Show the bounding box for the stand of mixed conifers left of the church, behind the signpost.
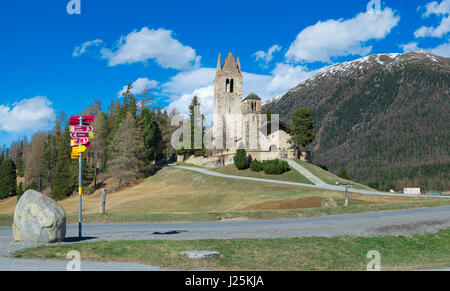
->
[0,85,176,200]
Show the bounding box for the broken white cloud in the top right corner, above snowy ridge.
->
[414,0,450,38]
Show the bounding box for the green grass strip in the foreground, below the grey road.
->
[15,229,450,271]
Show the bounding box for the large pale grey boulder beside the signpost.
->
[13,190,66,243]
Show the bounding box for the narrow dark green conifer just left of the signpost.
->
[52,126,74,200]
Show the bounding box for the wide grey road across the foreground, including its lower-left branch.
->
[0,206,450,270]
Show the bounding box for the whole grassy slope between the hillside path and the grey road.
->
[0,168,450,226]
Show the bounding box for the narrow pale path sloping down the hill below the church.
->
[169,164,450,199]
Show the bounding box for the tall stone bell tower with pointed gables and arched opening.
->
[213,53,243,152]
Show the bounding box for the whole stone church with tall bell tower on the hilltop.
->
[182,53,295,167]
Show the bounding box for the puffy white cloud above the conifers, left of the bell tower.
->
[101,27,200,69]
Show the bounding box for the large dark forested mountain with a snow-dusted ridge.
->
[266,52,450,190]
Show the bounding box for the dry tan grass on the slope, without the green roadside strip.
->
[0,168,446,219]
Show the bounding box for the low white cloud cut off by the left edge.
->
[0,96,56,133]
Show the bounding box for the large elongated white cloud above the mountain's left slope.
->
[285,8,400,63]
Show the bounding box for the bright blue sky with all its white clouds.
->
[0,0,450,145]
